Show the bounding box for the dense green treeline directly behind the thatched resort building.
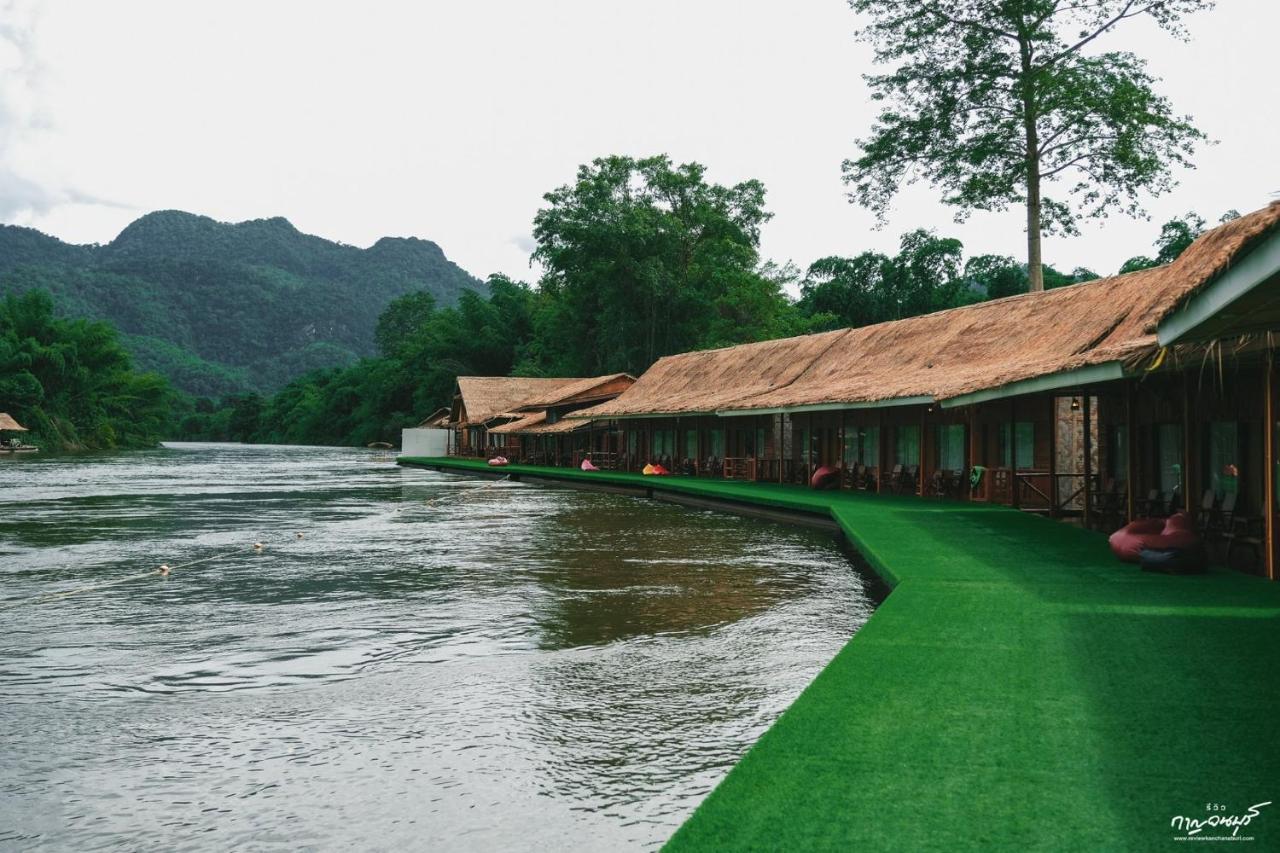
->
[179,158,1203,444]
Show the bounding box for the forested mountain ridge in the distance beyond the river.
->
[0,210,485,396]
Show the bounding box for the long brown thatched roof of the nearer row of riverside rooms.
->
[586,202,1280,418]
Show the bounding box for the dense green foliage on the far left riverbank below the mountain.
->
[0,291,172,450]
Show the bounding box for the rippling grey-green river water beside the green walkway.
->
[0,444,873,850]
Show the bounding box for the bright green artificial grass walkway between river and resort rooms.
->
[402,457,1280,850]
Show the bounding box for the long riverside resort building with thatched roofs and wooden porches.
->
[444,202,1280,579]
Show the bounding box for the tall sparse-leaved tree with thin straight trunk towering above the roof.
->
[844,0,1212,291]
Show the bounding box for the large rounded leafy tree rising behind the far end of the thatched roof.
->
[532,156,769,375]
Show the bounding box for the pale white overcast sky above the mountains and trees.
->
[0,0,1280,285]
